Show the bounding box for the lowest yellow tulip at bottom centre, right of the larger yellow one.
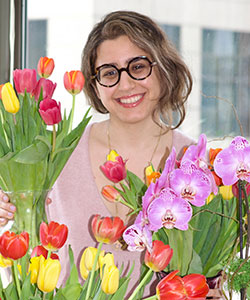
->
[101,265,119,295]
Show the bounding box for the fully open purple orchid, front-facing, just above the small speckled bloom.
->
[147,188,192,231]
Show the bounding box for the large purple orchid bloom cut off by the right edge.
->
[214,136,250,185]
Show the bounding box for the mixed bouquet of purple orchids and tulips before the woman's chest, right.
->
[101,134,250,298]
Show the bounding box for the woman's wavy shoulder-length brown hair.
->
[81,11,192,128]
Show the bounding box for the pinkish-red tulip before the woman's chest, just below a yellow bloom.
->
[100,156,127,183]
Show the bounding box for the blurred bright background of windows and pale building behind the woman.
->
[0,0,250,144]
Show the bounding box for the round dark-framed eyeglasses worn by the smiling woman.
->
[91,56,157,87]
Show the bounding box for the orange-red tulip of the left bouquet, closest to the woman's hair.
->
[63,71,85,95]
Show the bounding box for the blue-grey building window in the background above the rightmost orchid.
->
[202,29,250,136]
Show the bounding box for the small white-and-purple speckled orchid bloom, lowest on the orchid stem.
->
[123,223,152,252]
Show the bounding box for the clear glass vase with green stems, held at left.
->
[5,190,49,249]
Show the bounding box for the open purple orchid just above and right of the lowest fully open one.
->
[169,160,211,207]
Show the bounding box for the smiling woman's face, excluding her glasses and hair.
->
[95,35,160,123]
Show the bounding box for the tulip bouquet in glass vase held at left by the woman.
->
[0,57,90,248]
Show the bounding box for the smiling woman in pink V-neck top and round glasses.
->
[0,11,219,294]
